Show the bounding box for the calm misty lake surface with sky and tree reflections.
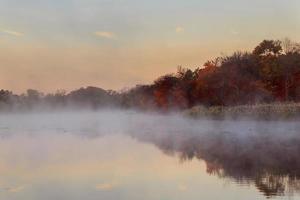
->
[0,112,300,200]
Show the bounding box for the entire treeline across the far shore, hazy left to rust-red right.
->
[0,39,300,110]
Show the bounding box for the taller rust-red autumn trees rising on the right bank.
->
[124,39,300,109]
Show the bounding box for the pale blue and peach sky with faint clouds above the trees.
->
[0,0,300,93]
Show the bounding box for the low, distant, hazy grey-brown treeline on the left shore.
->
[0,87,120,111]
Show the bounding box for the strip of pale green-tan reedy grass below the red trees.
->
[184,103,300,120]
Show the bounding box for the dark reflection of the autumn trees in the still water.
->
[132,130,300,197]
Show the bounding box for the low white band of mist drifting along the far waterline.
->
[0,109,300,137]
